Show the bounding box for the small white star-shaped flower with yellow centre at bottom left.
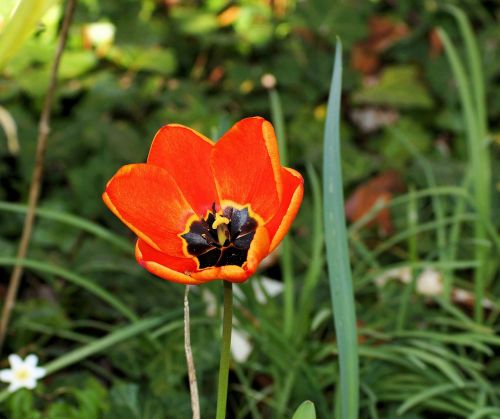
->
[0,354,46,393]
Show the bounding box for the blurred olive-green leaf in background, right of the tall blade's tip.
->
[353,65,433,109]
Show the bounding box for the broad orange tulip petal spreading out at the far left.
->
[103,164,193,257]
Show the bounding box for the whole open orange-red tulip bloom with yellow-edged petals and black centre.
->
[103,117,303,284]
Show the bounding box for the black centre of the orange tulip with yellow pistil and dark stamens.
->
[181,204,258,269]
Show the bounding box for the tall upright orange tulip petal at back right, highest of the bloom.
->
[211,117,282,221]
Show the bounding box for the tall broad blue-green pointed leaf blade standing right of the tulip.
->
[323,40,359,419]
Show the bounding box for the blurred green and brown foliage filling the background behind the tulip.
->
[0,0,500,419]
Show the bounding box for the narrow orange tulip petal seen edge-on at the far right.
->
[266,167,304,252]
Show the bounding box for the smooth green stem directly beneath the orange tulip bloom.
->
[216,281,233,419]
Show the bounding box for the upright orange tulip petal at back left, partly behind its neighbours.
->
[148,124,219,215]
